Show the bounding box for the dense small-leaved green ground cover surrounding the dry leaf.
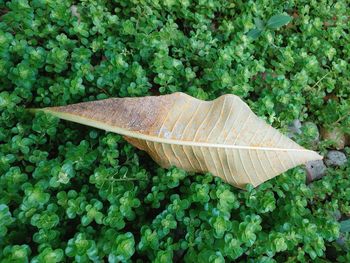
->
[0,0,350,263]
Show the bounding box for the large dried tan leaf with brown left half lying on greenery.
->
[33,93,322,188]
